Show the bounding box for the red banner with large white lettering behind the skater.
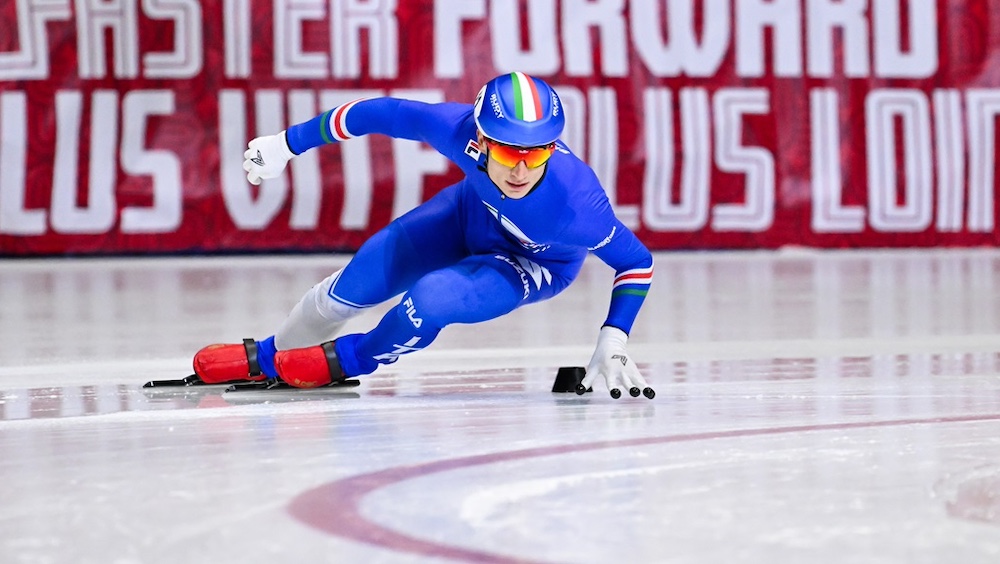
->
[0,0,1000,256]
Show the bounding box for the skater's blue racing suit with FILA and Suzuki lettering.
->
[262,98,653,376]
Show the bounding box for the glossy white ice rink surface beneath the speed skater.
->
[0,249,1000,564]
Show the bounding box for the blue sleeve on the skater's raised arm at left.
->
[288,98,472,161]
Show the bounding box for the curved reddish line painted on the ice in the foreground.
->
[288,414,1000,563]
